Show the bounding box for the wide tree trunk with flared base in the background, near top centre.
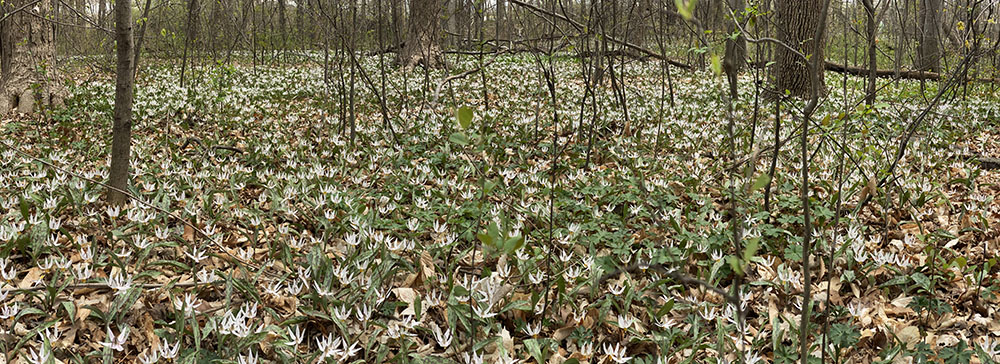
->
[396,0,446,68]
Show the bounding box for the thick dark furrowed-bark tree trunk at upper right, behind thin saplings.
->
[774,0,826,97]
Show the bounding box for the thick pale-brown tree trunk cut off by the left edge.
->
[0,0,63,115]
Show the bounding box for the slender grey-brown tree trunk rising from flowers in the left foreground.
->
[108,0,134,205]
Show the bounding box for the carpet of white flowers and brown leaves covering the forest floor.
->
[0,56,1000,363]
